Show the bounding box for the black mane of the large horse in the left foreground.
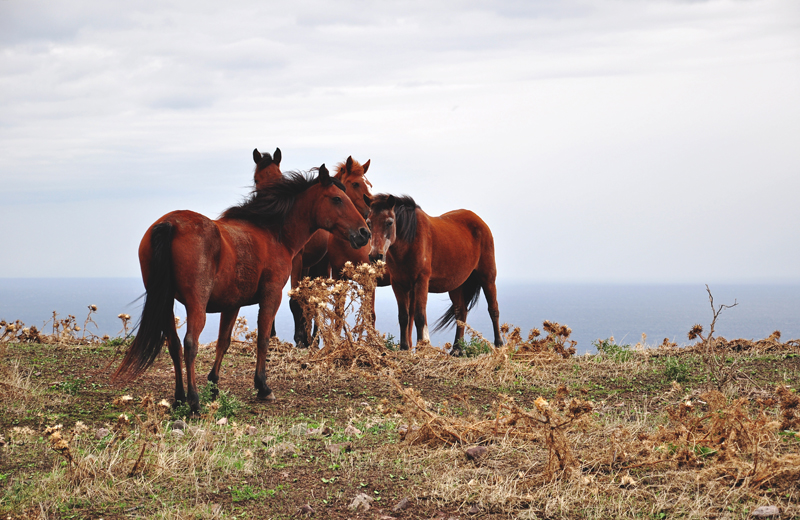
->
[220,170,346,231]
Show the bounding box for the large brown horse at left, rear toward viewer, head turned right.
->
[114,164,370,412]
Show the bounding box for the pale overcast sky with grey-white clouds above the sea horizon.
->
[0,0,800,283]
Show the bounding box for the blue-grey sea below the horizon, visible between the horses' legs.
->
[0,278,800,353]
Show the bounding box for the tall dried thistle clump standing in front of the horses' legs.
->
[289,262,395,368]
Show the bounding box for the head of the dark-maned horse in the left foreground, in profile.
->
[313,164,370,249]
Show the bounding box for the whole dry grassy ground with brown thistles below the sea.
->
[0,294,800,519]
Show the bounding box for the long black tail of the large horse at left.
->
[112,222,175,381]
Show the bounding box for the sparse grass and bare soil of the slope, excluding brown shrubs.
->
[0,344,800,518]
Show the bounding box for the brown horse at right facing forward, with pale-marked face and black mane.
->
[365,194,503,354]
